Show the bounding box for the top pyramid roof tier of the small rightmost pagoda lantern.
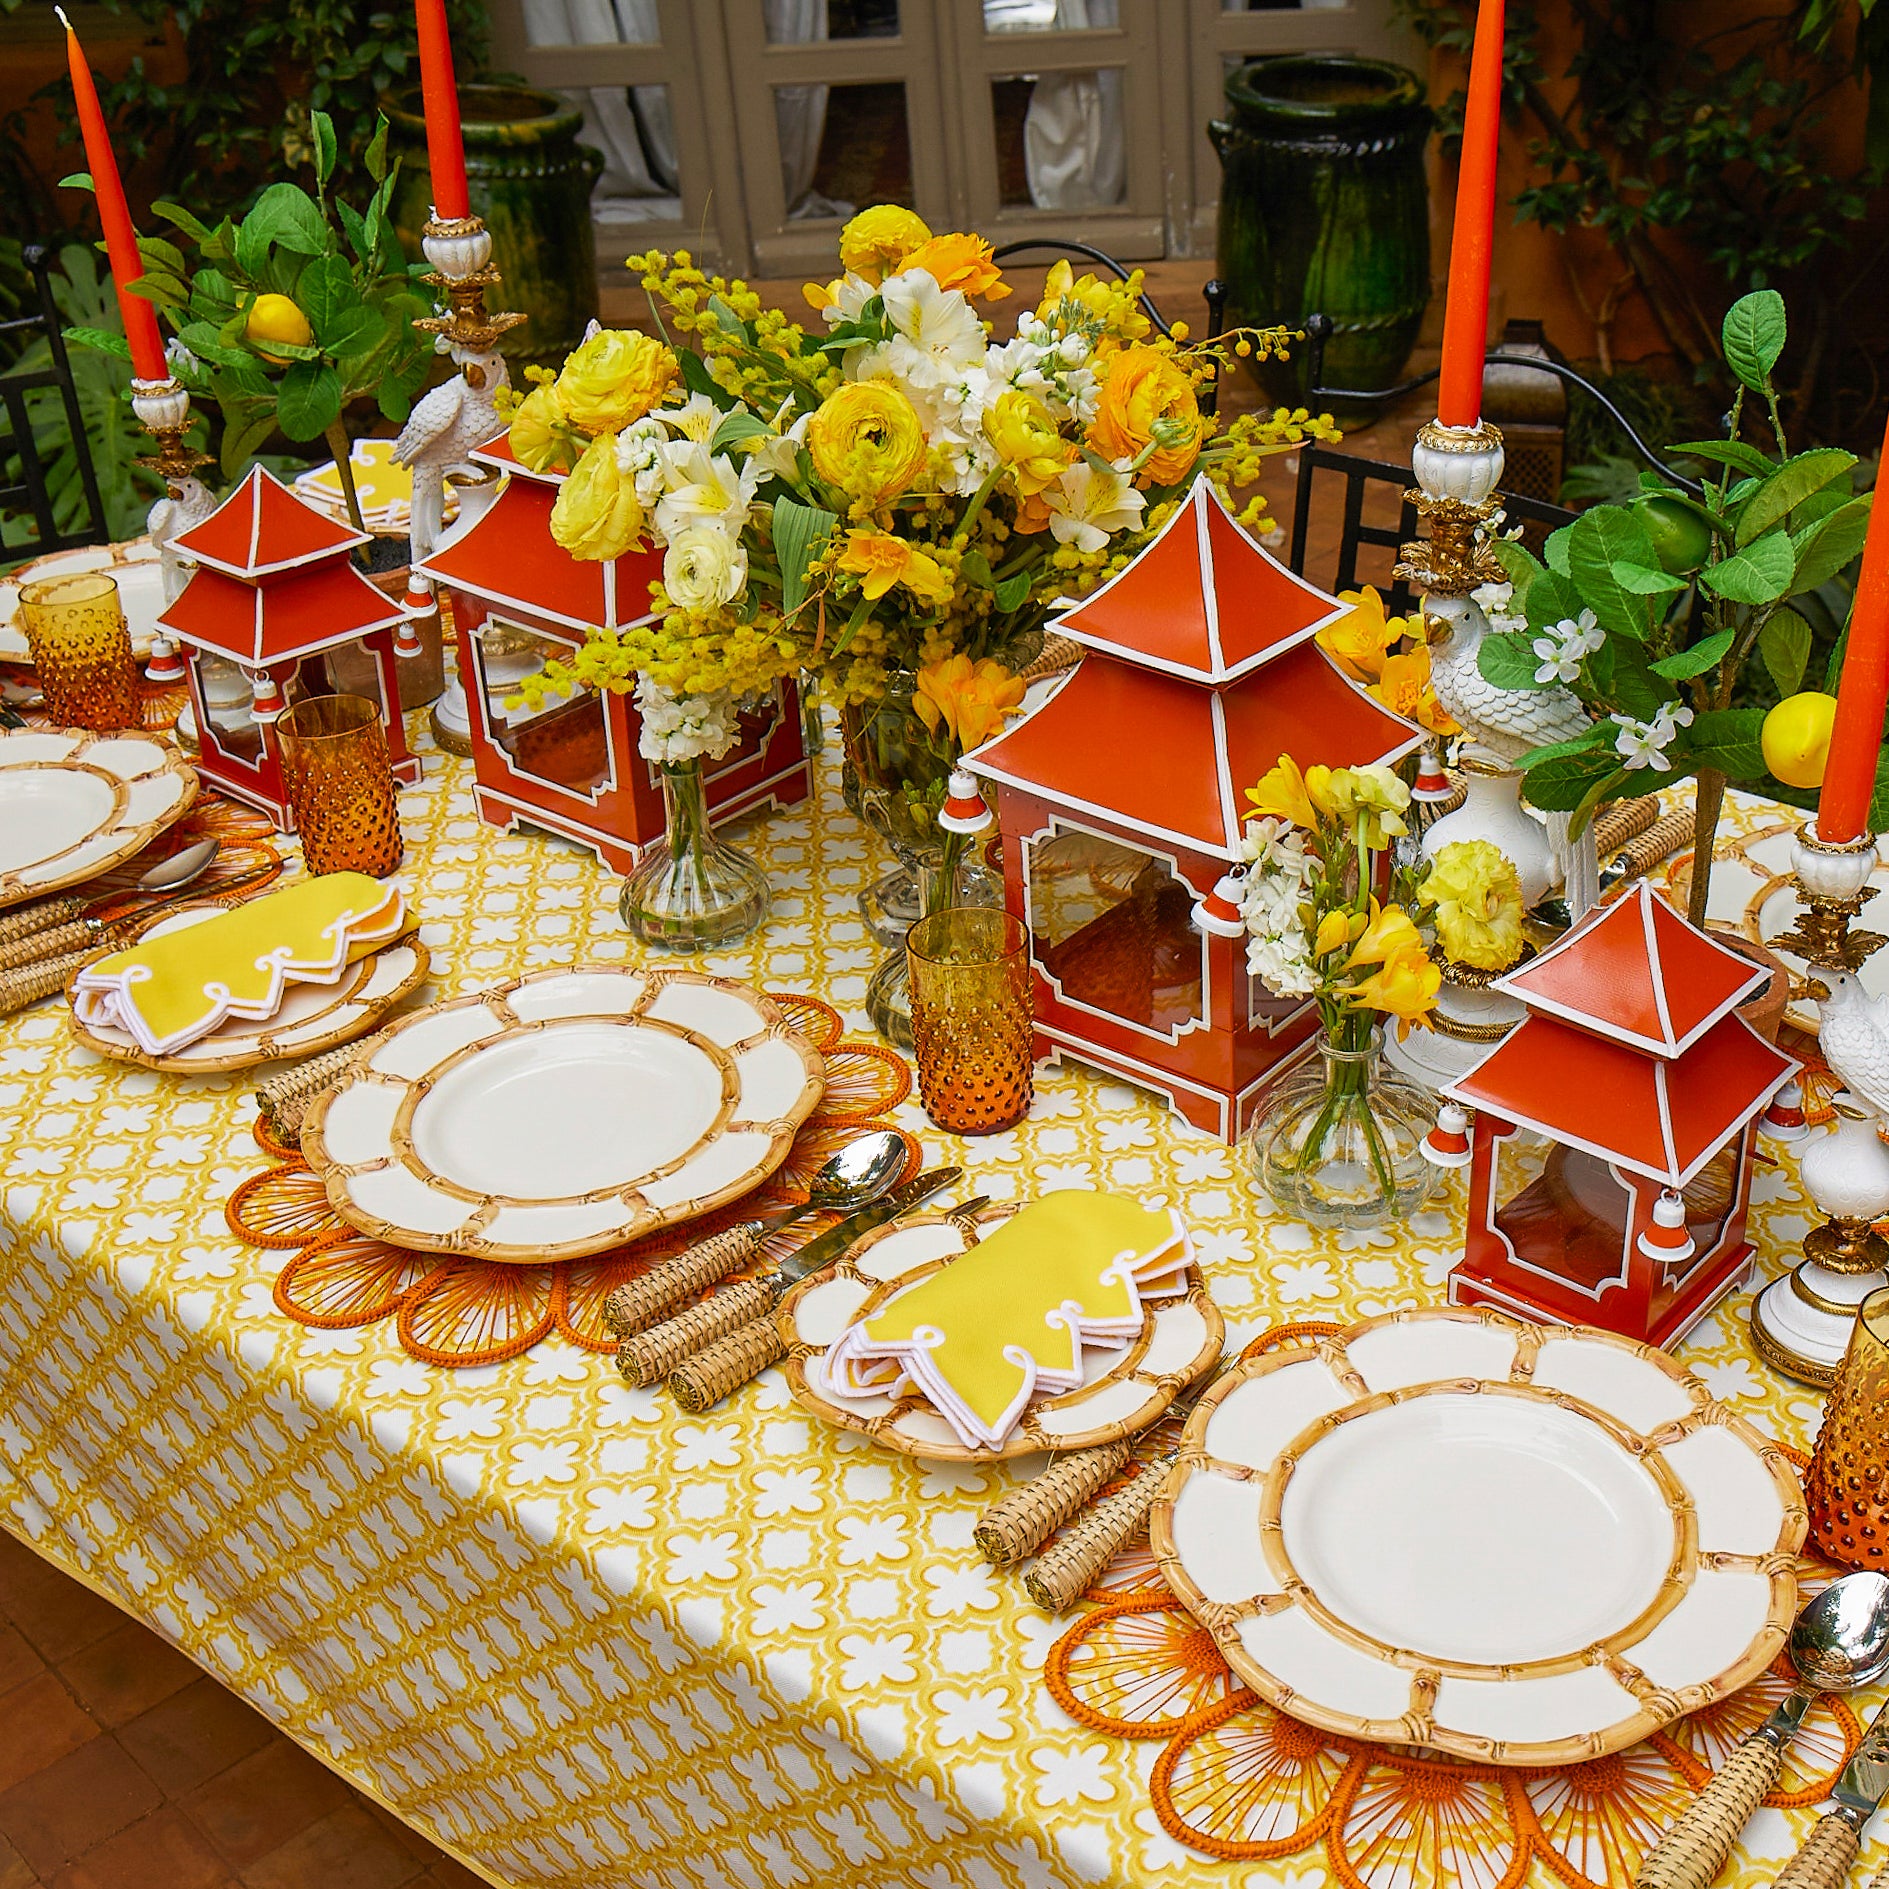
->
[1494,880,1770,1056]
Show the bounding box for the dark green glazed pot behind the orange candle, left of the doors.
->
[387,85,603,365]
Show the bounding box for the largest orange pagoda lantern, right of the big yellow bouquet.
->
[965,480,1422,1141]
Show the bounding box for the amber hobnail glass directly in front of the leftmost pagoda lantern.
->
[276,695,400,878]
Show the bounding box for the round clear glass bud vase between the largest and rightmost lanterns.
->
[1247,1030,1436,1228]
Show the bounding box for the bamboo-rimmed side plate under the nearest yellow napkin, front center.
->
[774,1207,1226,1462]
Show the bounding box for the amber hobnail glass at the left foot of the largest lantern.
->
[905,905,1033,1135]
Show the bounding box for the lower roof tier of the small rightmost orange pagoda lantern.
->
[1443,1016,1796,1188]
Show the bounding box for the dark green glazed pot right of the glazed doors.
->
[1207,53,1430,406]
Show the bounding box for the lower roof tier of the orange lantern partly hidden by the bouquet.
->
[419,476,663,631]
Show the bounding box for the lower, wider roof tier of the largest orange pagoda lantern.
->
[965,646,1424,859]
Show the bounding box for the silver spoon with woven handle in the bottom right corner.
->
[1634,1572,1889,1889]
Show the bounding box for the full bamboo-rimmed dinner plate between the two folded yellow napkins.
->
[302,965,825,1264]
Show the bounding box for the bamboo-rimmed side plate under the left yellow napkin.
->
[66,899,427,1075]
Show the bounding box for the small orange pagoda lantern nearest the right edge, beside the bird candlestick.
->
[1432,882,1796,1345]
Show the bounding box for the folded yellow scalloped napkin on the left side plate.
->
[72,873,406,1056]
